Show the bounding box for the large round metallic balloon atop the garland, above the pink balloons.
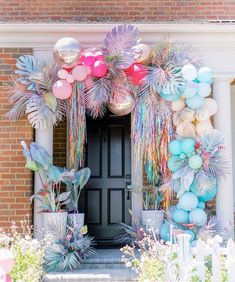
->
[53,37,82,68]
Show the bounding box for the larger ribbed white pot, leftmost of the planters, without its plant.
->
[42,212,68,240]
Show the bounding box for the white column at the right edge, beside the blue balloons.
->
[213,77,234,237]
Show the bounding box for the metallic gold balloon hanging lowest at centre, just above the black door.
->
[108,93,136,116]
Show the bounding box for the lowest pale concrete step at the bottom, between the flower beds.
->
[43,268,136,282]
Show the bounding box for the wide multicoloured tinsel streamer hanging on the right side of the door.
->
[132,93,174,207]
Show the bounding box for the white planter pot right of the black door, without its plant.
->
[142,210,164,234]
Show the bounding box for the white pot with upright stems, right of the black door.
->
[142,185,164,233]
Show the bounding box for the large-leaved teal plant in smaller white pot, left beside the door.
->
[61,167,91,228]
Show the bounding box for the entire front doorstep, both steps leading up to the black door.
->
[43,249,136,282]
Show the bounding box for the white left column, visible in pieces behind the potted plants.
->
[33,127,53,238]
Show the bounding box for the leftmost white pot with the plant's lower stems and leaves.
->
[30,181,70,240]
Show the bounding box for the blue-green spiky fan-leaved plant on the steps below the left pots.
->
[44,218,95,272]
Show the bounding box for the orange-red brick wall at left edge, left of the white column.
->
[0,48,33,228]
